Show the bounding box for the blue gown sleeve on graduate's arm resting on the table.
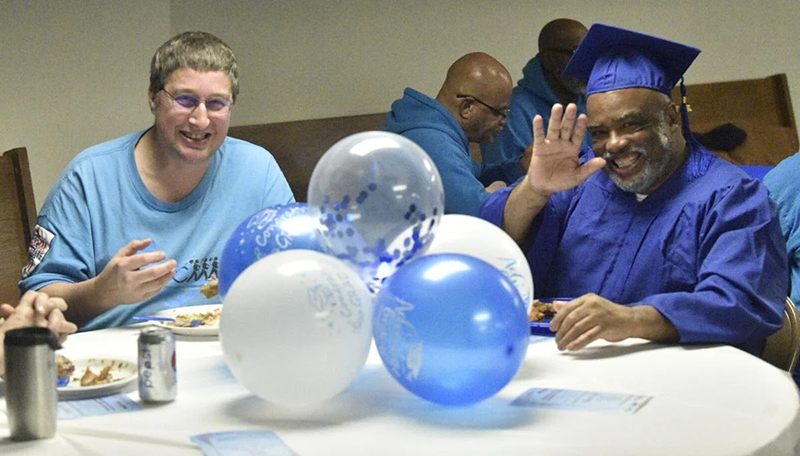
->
[631,180,788,348]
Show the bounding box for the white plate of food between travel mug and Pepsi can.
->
[58,358,138,399]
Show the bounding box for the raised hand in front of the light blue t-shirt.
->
[92,239,177,308]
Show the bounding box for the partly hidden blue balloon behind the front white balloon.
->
[217,203,323,296]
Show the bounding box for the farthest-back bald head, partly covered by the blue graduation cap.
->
[539,19,588,103]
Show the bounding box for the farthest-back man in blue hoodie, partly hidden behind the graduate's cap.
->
[481,19,591,184]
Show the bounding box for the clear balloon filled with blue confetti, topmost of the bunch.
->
[308,131,444,291]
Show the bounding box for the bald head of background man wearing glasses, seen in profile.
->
[436,52,513,143]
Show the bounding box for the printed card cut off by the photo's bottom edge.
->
[192,430,299,456]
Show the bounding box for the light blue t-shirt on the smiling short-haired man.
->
[20,131,294,330]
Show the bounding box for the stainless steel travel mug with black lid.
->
[3,328,60,440]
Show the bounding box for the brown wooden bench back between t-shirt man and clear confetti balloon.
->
[228,113,386,202]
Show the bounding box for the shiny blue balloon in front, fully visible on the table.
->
[372,254,529,406]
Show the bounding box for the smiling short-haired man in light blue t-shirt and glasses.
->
[20,32,294,330]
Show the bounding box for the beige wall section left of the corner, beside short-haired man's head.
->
[0,0,170,207]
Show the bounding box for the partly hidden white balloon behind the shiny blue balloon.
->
[425,214,533,313]
